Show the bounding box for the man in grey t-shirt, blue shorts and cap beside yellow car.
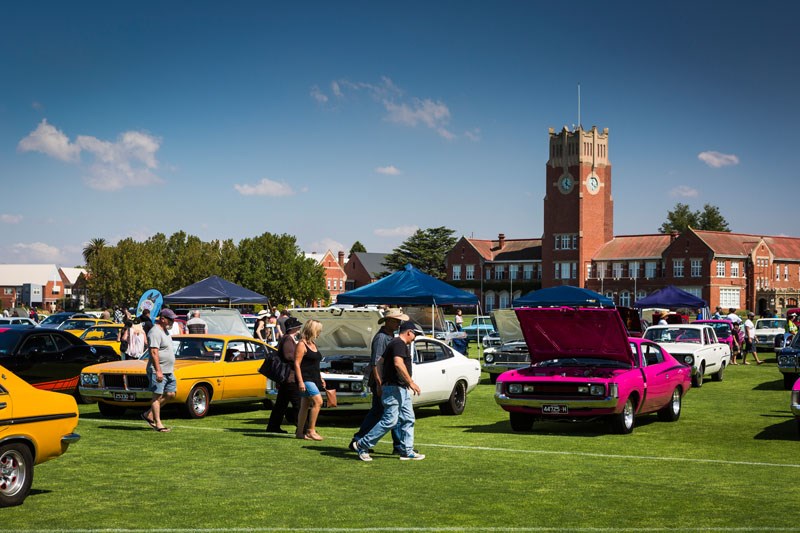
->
[142,309,178,433]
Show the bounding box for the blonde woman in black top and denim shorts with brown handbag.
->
[294,320,325,440]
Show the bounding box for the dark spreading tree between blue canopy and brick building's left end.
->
[381,226,457,279]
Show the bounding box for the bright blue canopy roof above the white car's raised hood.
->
[336,264,478,305]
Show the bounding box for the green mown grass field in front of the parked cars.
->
[7,352,800,531]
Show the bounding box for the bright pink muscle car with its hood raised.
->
[495,307,692,433]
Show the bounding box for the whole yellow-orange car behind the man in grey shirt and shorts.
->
[78,334,273,418]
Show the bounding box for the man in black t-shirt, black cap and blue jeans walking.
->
[350,320,425,461]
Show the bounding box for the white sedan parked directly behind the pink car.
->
[644,324,731,387]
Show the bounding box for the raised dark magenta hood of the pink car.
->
[515,307,633,364]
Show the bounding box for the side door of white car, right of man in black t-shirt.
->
[411,338,453,403]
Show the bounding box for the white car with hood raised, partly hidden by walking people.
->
[267,307,481,415]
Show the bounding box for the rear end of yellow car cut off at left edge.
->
[0,366,80,507]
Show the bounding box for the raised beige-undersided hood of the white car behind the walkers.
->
[289,307,383,357]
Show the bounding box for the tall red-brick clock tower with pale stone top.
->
[542,126,614,287]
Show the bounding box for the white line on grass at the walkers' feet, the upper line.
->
[76,418,800,468]
